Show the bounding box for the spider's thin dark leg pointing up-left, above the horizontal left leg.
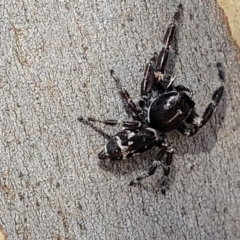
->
[110,70,141,115]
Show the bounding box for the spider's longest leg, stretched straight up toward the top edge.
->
[154,4,182,81]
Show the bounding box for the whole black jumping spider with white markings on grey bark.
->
[78,5,224,194]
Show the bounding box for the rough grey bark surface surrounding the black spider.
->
[0,0,240,240]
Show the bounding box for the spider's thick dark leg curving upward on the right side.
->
[177,86,224,136]
